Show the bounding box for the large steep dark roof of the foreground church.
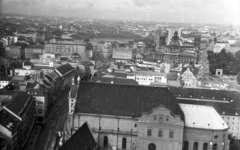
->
[76,82,184,120]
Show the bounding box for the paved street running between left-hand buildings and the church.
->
[34,90,68,150]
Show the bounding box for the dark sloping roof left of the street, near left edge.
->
[6,91,33,117]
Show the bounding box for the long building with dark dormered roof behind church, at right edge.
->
[170,87,240,139]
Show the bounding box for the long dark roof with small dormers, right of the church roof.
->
[170,87,240,115]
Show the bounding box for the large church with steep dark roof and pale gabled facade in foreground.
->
[68,82,229,150]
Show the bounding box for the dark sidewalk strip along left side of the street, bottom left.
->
[23,125,42,150]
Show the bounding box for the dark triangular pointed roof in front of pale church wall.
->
[60,122,97,150]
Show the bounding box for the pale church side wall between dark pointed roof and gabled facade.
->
[73,114,137,150]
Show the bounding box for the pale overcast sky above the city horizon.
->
[0,0,240,25]
